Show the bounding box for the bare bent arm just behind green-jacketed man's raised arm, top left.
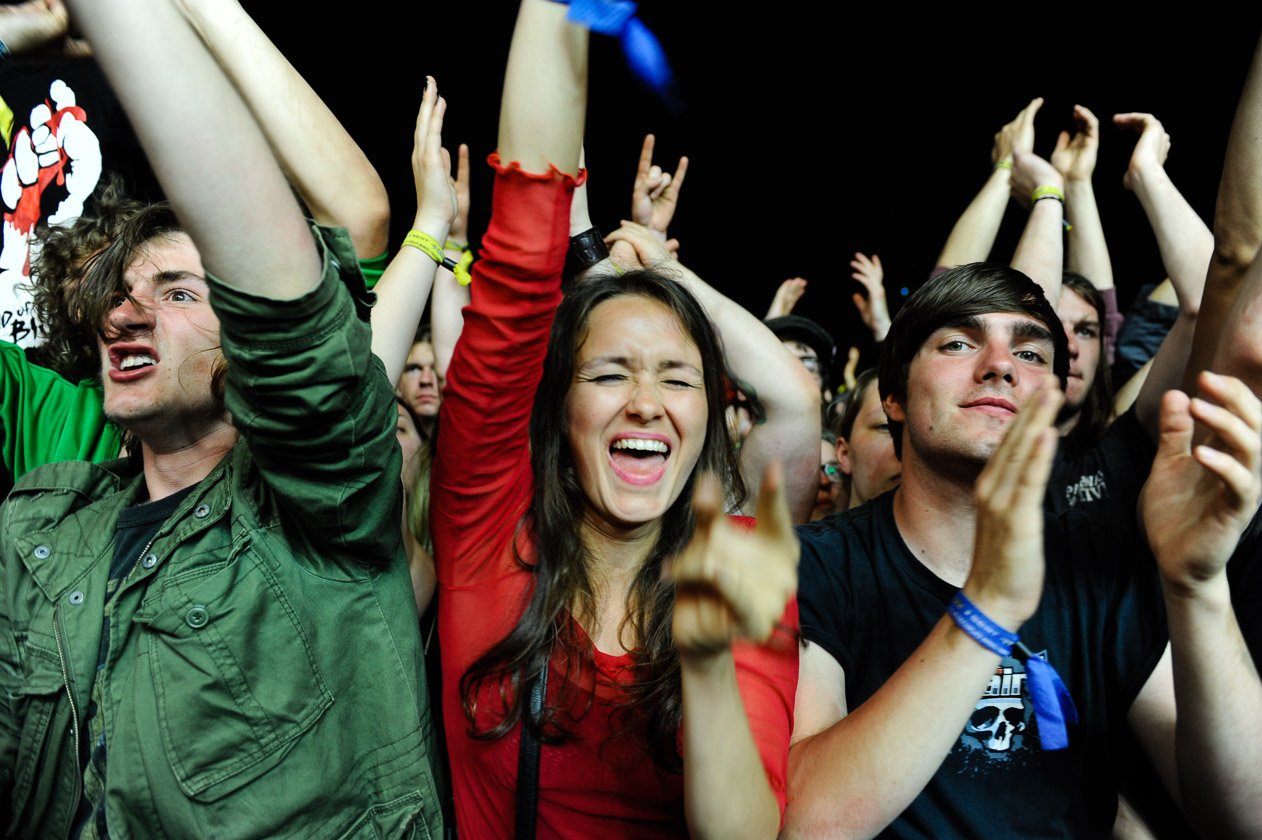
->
[175,0,390,260]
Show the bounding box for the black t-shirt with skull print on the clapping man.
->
[798,492,1166,839]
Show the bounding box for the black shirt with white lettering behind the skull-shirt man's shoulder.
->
[1044,407,1157,518]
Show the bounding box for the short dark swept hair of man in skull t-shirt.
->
[877,262,1069,459]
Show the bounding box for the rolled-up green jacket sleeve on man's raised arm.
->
[209,226,403,565]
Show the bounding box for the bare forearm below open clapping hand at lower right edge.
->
[1165,571,1262,837]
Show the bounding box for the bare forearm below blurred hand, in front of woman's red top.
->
[680,650,780,837]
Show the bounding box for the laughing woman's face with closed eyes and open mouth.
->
[564,295,708,531]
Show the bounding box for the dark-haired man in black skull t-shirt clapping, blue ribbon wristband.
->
[785,265,1262,837]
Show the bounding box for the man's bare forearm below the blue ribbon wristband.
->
[784,615,1000,837]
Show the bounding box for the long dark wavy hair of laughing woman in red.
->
[461,270,745,772]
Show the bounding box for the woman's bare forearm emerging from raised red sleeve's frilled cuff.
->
[500,0,588,173]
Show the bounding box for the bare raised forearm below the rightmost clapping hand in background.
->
[1131,168,1214,314]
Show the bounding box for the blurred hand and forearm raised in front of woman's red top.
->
[670,465,799,839]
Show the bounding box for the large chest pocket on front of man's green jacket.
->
[136,539,333,802]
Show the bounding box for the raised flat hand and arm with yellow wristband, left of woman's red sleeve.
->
[372,78,457,385]
